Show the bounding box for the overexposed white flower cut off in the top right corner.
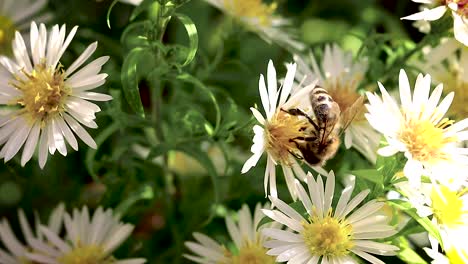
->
[401,0,468,46]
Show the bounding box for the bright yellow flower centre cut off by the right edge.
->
[431,185,468,227]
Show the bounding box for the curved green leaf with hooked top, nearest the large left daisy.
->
[120,48,152,117]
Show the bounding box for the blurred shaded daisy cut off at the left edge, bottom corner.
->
[0,204,65,264]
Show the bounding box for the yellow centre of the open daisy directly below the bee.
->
[302,211,353,257]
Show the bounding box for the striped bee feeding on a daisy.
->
[282,87,364,166]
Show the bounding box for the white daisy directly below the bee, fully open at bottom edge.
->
[263,172,398,264]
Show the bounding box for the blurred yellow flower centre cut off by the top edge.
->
[224,0,277,26]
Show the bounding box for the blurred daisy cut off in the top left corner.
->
[0,0,51,54]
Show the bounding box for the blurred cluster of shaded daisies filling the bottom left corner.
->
[0,204,146,264]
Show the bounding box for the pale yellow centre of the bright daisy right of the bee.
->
[399,117,456,163]
